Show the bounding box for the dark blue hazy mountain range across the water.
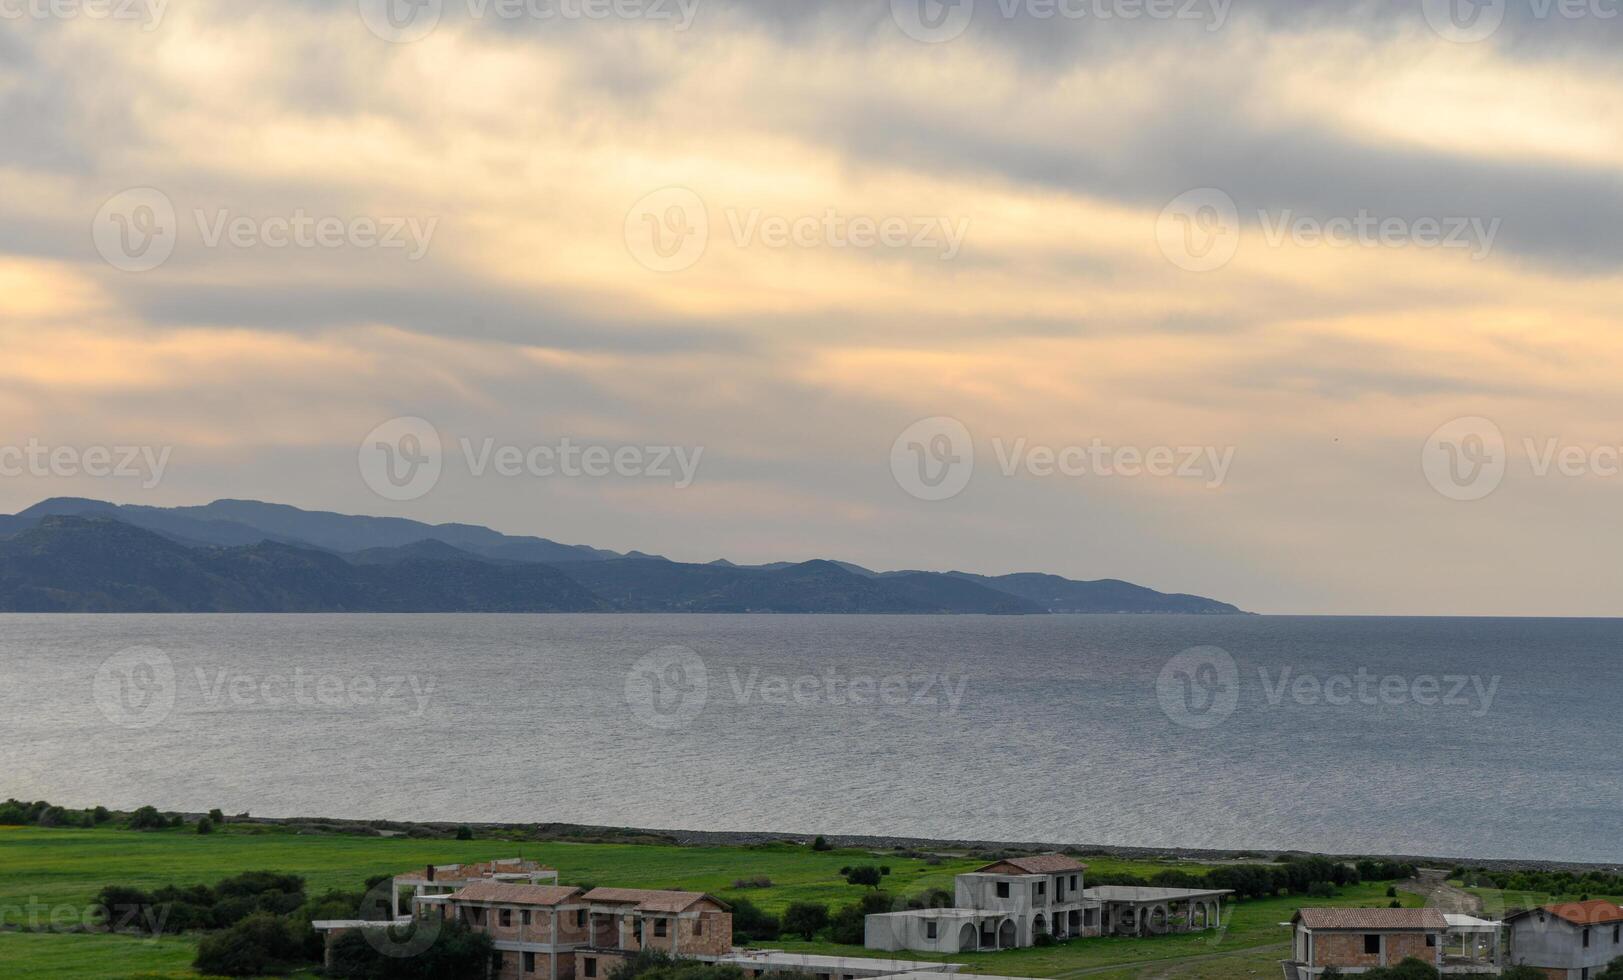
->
[0,498,1240,615]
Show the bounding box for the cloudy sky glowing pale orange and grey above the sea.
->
[0,0,1623,615]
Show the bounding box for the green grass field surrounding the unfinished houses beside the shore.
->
[0,826,1571,980]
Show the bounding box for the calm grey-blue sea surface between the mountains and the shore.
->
[0,615,1623,862]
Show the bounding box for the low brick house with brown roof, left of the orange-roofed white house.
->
[1285,909,1448,980]
